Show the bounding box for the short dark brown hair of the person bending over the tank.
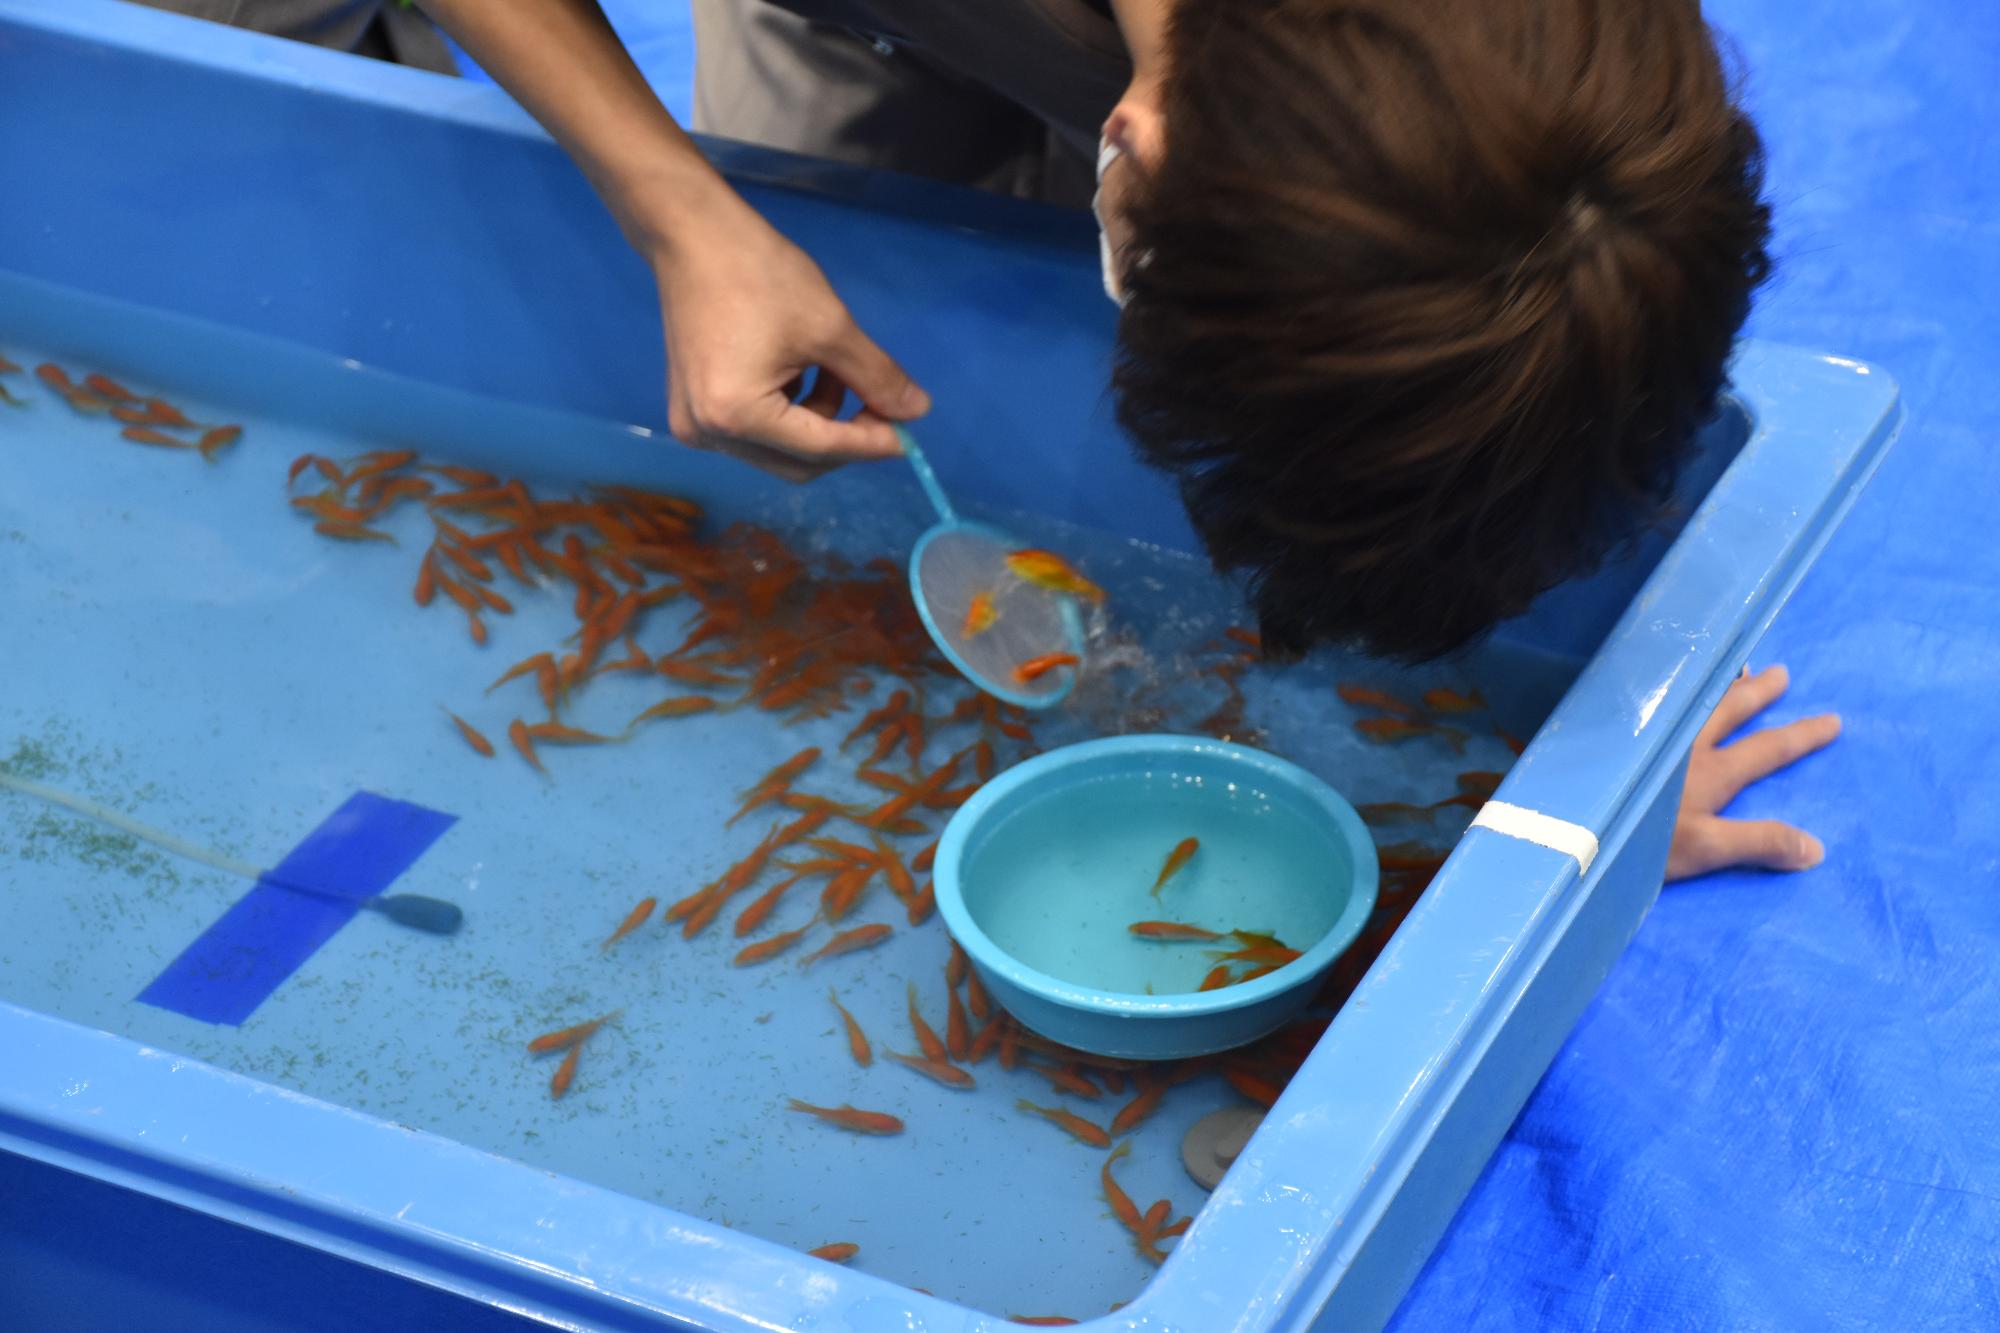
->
[1116,0,1770,656]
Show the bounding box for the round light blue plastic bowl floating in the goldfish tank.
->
[934,735,1378,1059]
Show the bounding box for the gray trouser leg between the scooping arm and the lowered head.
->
[692,0,1110,208]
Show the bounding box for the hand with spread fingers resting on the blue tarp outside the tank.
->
[1666,667,1840,881]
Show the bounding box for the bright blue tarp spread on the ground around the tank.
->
[372,0,2000,1333]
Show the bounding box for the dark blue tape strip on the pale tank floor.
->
[138,791,458,1025]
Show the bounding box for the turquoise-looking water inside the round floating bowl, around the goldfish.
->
[964,771,1354,995]
